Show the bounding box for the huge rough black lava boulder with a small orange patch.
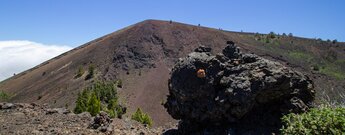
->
[164,41,315,134]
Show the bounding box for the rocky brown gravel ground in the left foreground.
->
[0,103,175,135]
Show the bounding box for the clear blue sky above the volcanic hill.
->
[0,0,345,47]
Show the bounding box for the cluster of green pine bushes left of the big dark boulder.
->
[74,81,126,118]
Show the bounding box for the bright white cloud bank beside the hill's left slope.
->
[0,40,72,81]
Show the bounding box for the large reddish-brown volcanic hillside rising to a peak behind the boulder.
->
[0,20,345,126]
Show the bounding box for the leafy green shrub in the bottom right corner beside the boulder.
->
[280,107,345,135]
